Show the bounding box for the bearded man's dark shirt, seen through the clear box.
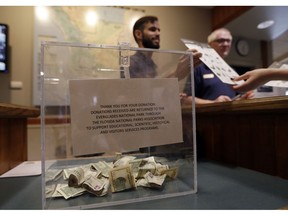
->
[129,51,157,78]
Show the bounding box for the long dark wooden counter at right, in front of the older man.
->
[182,96,288,179]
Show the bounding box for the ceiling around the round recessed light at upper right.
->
[226,6,288,59]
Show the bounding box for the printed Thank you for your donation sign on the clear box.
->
[69,78,183,156]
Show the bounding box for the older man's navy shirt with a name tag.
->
[184,63,237,100]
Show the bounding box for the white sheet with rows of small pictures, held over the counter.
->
[181,39,243,85]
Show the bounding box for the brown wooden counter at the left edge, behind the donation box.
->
[0,103,40,175]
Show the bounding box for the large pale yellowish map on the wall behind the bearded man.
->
[33,6,144,105]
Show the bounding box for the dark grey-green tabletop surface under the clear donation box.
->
[0,161,288,210]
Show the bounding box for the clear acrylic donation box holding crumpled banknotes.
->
[39,42,197,209]
